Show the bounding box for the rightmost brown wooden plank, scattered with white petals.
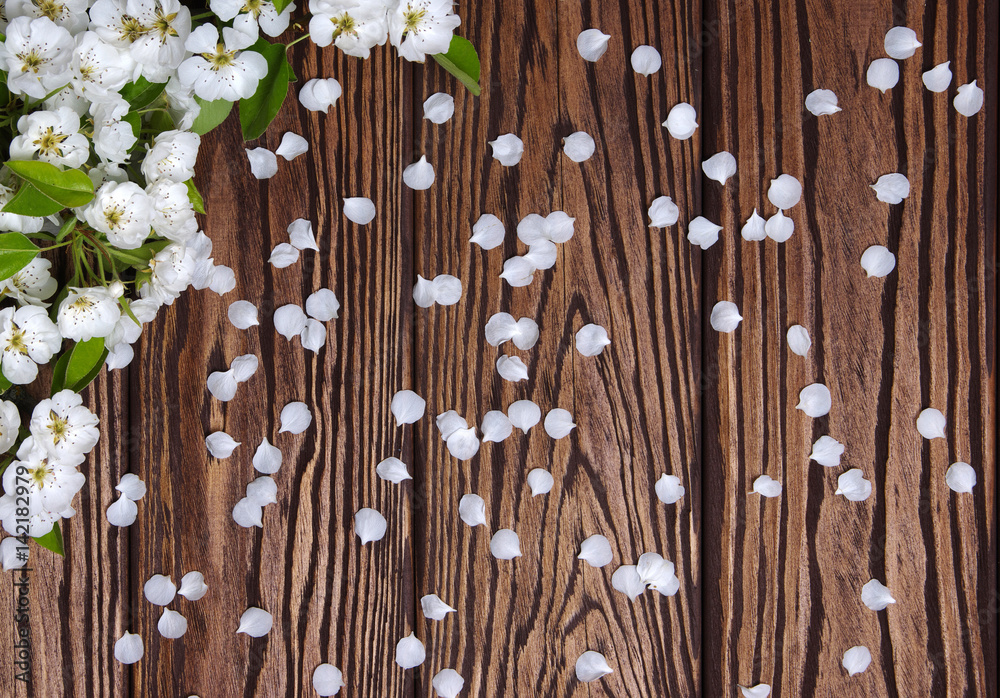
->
[703,0,996,696]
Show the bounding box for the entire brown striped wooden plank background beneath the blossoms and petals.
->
[0,0,1000,698]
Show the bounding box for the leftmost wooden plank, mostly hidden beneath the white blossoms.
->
[0,369,136,698]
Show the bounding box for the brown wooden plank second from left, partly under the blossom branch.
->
[132,44,413,696]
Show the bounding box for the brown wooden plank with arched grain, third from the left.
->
[414,2,699,696]
